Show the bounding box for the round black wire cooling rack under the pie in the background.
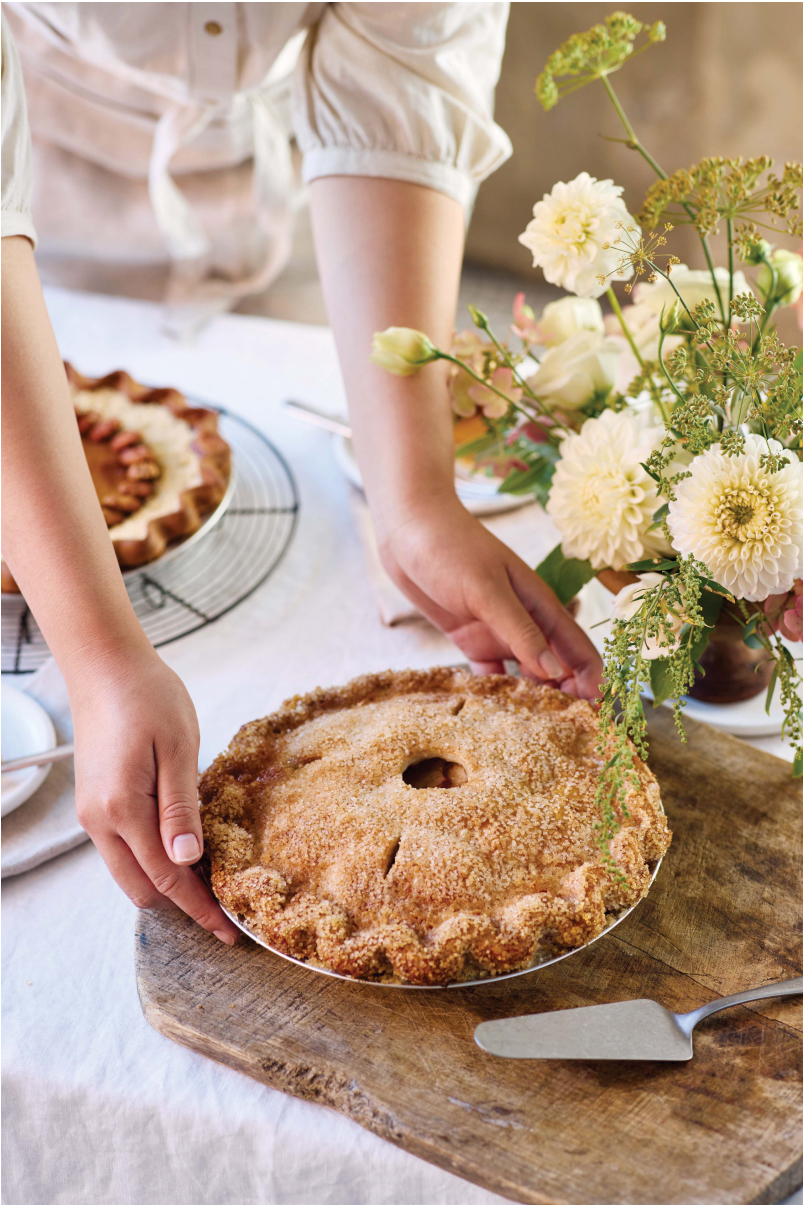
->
[2,407,299,674]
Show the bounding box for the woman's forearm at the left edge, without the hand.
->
[2,237,150,682]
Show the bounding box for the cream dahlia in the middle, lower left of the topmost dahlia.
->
[546,410,669,569]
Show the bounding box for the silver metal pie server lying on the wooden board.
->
[474,977,803,1063]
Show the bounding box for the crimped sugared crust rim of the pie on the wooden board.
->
[199,666,672,986]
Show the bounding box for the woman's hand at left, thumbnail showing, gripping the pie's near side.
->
[69,651,238,945]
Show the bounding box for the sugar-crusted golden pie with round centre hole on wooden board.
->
[200,668,672,984]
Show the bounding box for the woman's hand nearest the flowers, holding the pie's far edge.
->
[379,496,603,700]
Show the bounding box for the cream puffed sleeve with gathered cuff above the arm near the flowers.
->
[293,4,511,208]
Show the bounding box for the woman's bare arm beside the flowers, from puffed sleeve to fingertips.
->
[311,176,602,699]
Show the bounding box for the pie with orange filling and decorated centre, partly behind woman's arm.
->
[2,364,231,593]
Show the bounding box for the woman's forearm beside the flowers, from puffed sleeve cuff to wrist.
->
[311,176,464,537]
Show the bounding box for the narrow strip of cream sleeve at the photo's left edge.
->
[0,14,36,246]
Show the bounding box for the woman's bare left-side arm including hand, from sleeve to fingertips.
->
[2,237,236,944]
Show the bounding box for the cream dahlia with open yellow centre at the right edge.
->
[668,435,803,603]
